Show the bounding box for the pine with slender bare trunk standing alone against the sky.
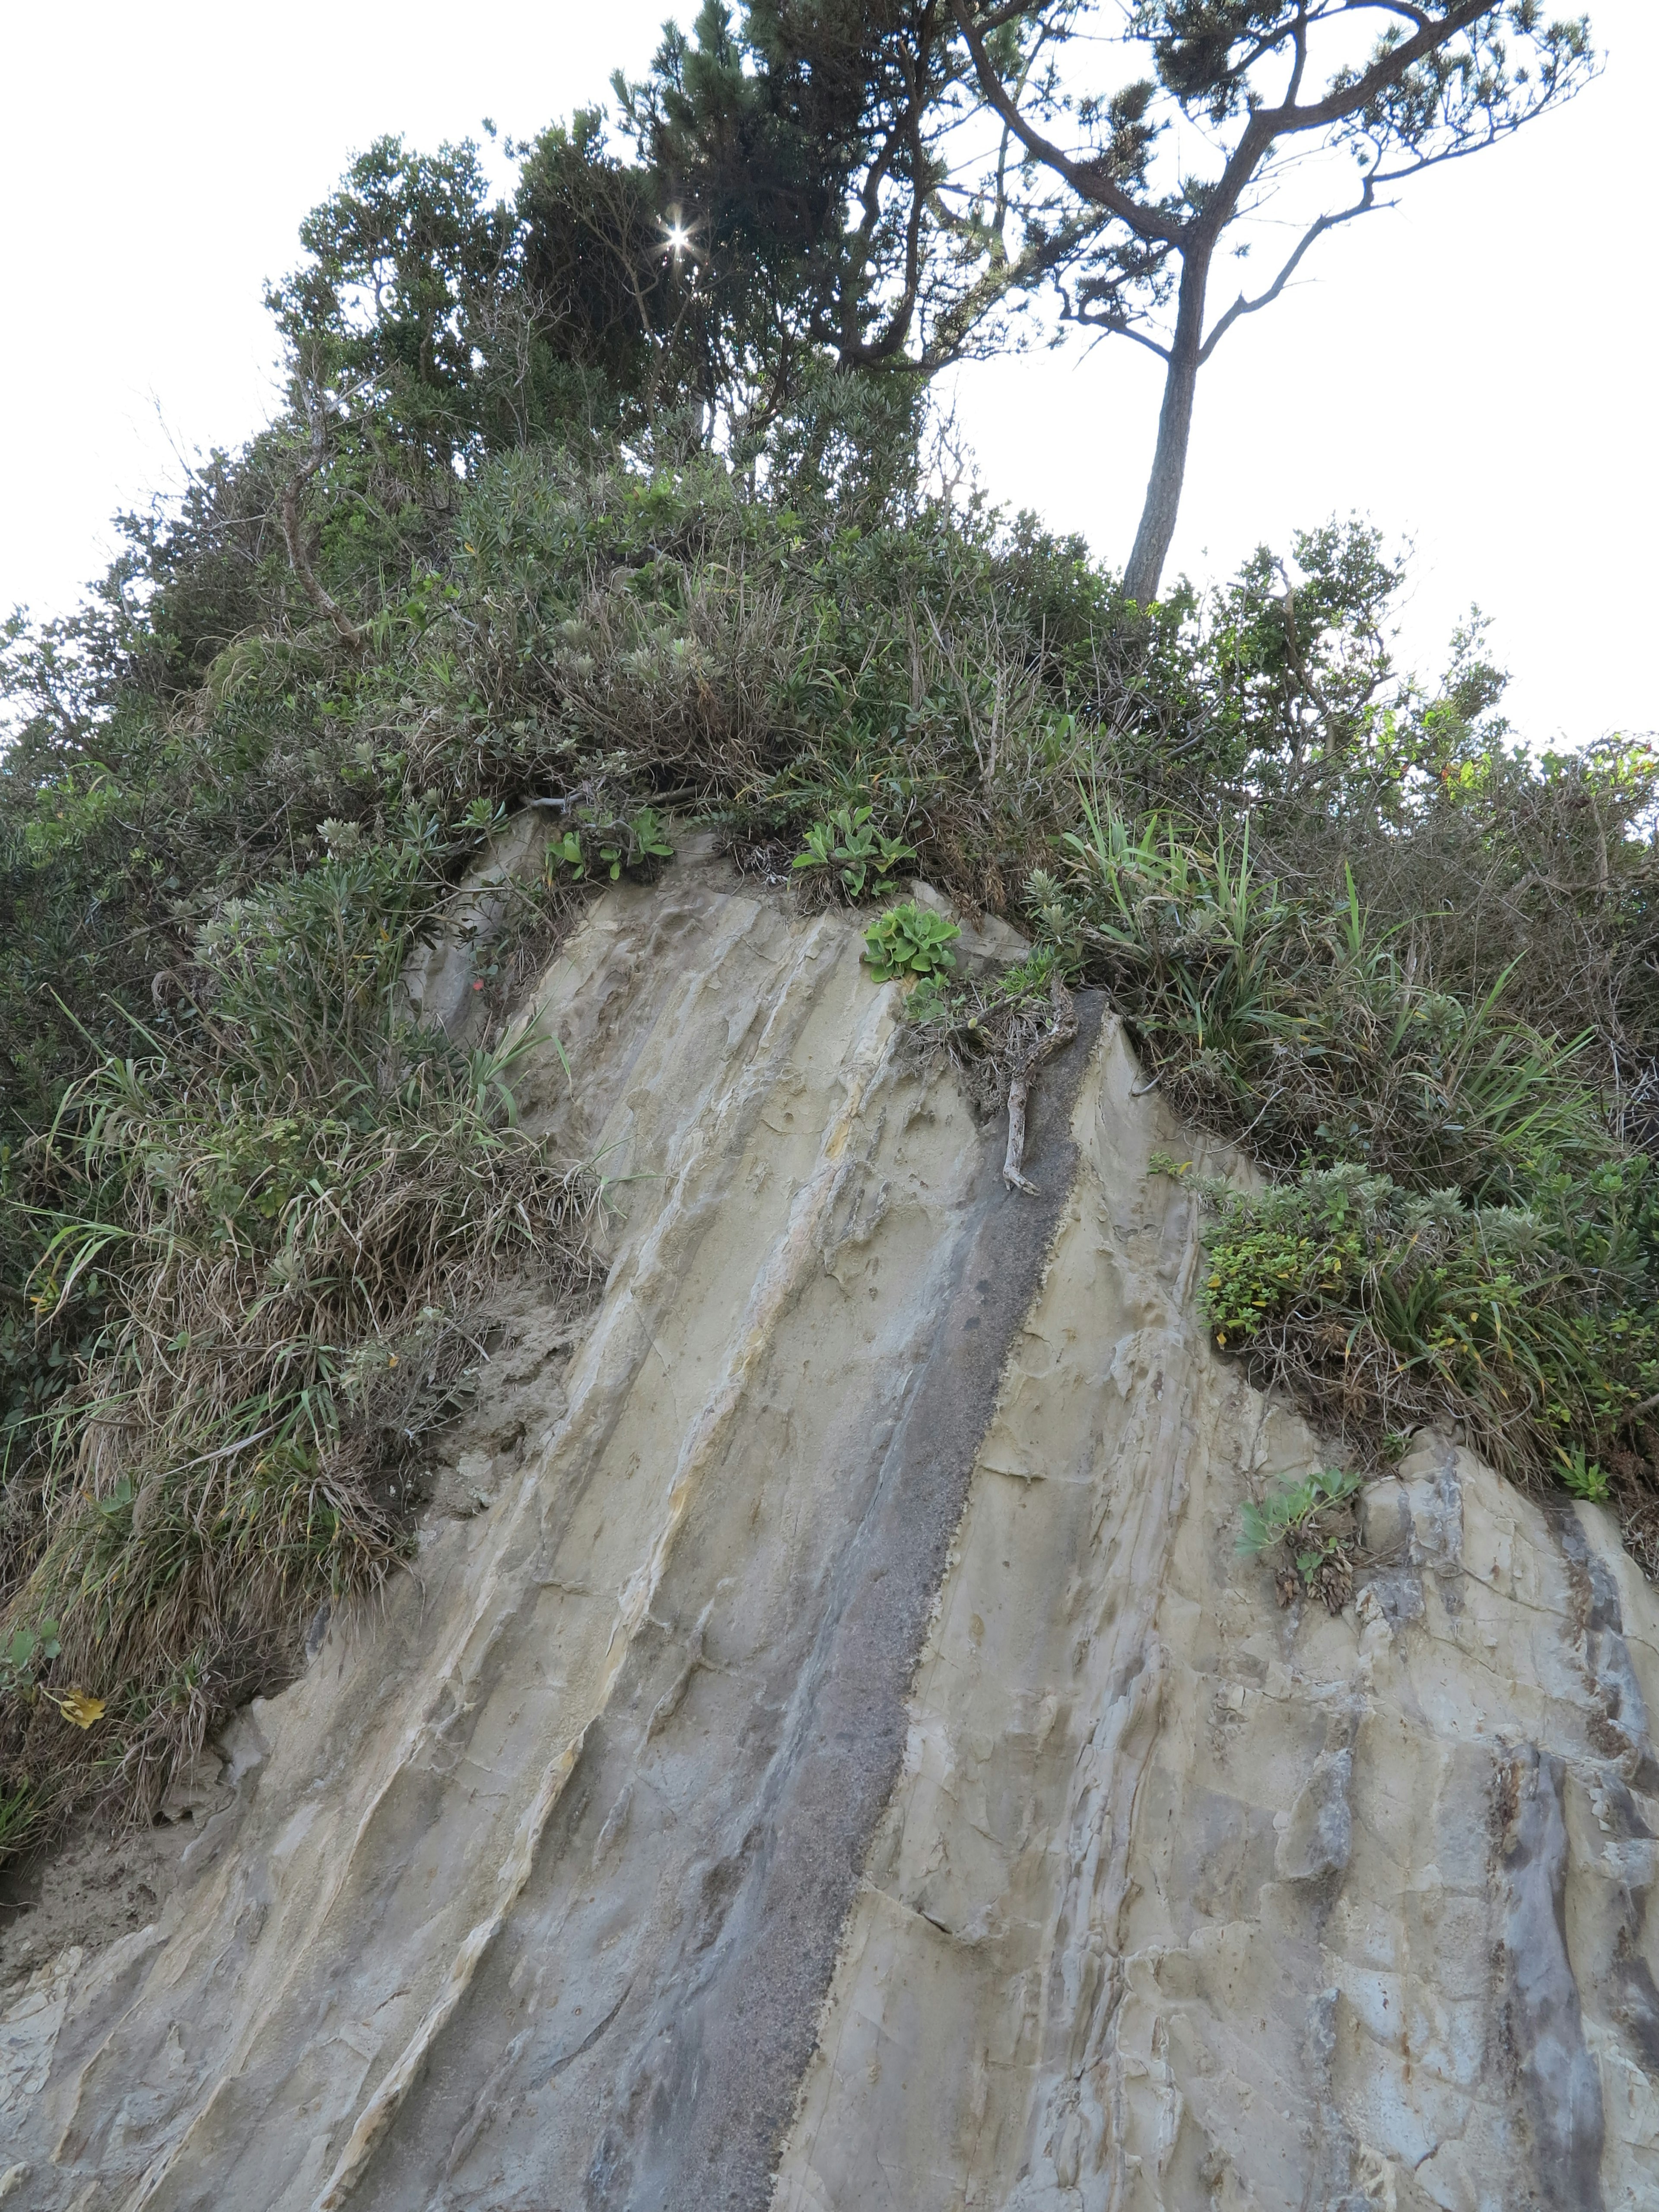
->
[951,0,1597,604]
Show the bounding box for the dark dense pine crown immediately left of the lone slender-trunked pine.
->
[615,0,1073,440]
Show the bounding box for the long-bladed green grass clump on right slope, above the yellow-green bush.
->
[1031,798,1608,1199]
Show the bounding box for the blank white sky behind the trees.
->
[0,0,1659,741]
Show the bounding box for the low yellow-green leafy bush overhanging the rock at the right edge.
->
[1199,1157,1659,1495]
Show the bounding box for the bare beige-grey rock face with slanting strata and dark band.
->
[0,863,1659,2212]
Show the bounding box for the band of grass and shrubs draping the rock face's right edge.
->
[1031,796,1659,1566]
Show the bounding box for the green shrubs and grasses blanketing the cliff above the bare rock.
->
[0,9,1659,1854]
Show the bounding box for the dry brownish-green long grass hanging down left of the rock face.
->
[0,865,600,1847]
